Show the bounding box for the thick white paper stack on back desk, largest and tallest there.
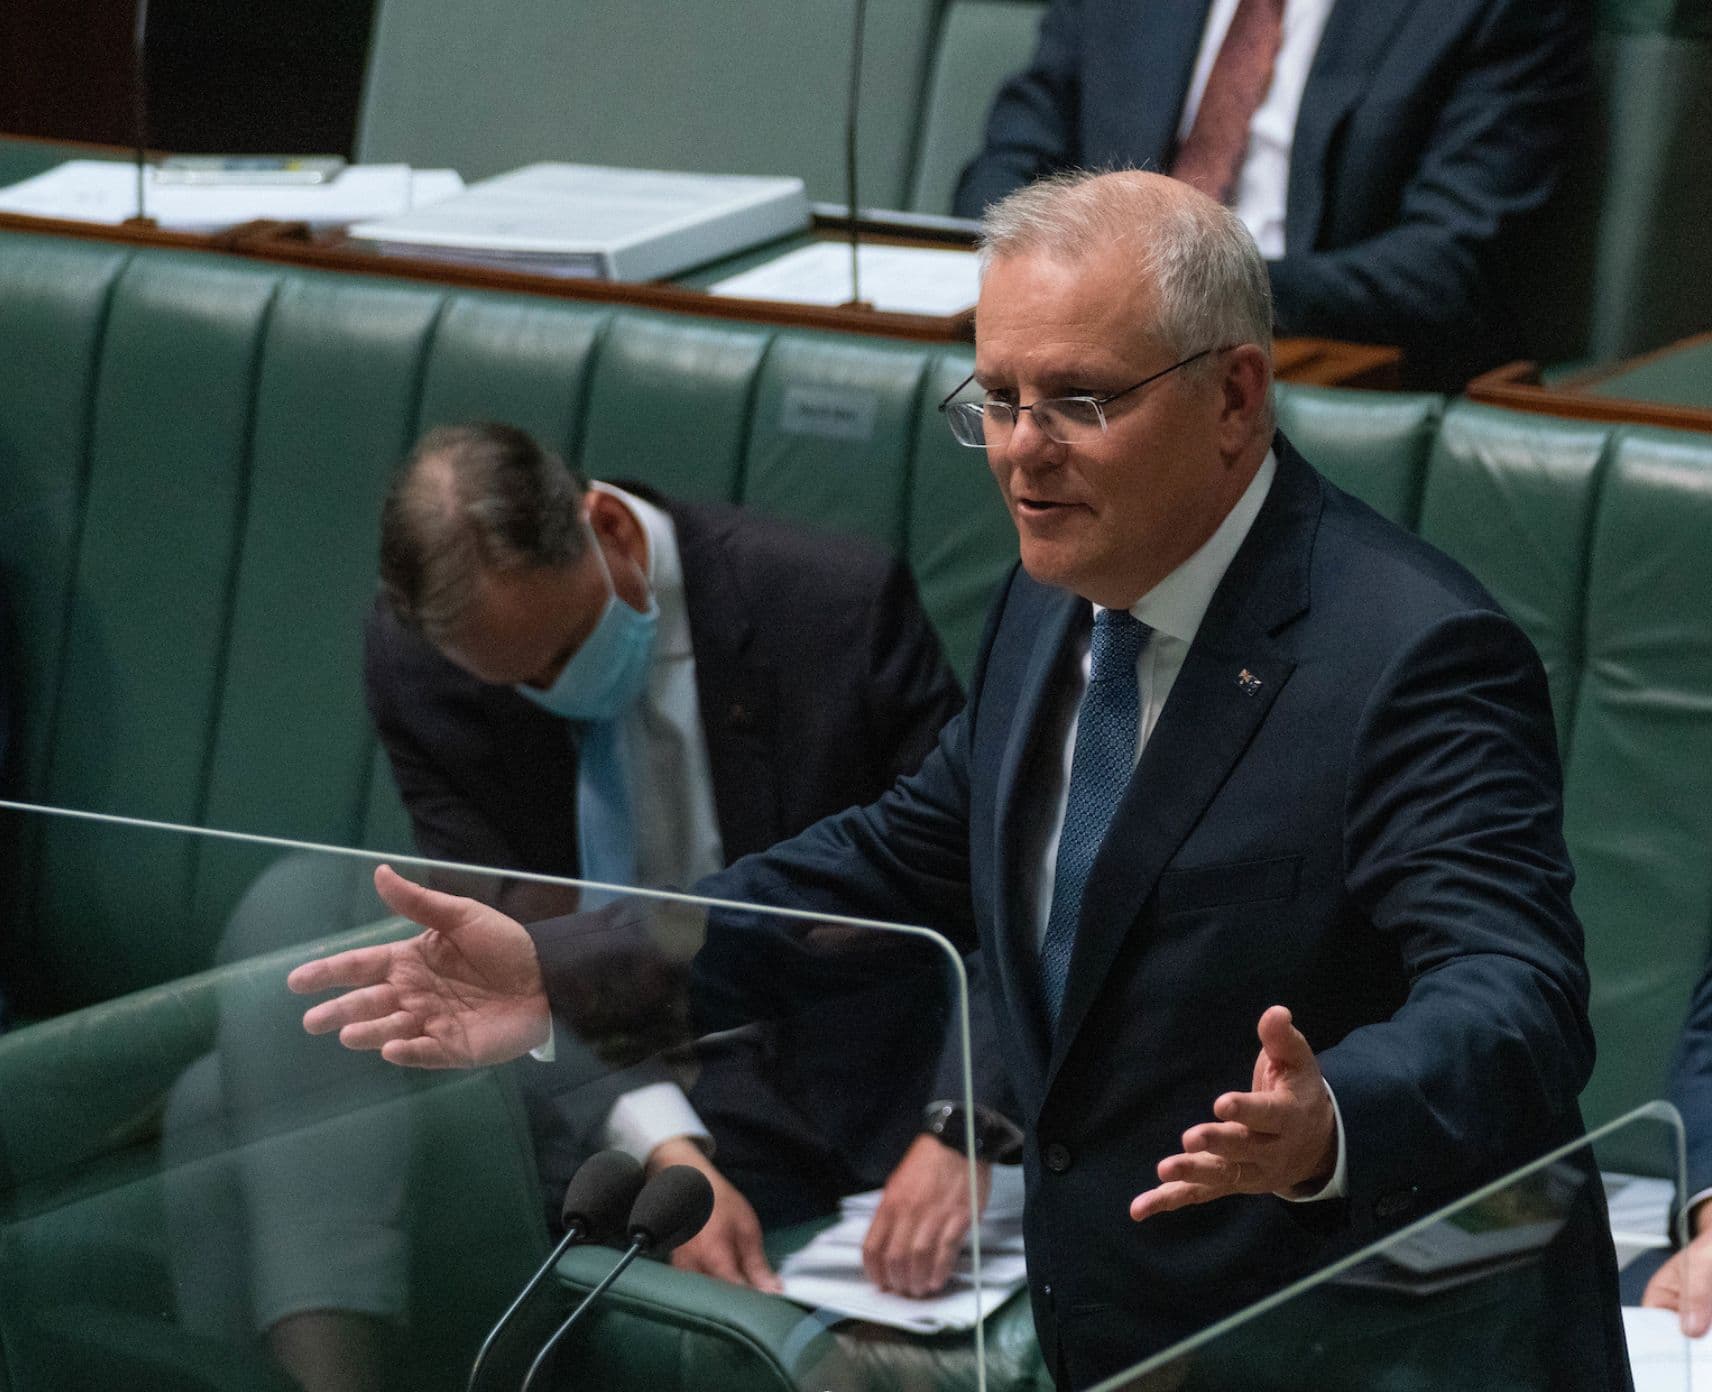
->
[351,164,808,281]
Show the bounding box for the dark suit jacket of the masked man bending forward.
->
[365,469,1003,1260]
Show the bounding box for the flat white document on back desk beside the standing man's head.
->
[707,241,981,315]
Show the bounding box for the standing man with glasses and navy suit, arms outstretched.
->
[291,173,1626,1387]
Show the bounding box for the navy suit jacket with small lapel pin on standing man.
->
[688,437,1625,1387]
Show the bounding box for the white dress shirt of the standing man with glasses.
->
[1027,452,1347,1199]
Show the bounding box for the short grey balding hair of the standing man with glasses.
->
[979,170,1272,366]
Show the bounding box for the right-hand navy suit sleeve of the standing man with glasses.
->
[1320,611,1594,1217]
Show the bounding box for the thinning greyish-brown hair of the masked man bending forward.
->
[380,421,589,642]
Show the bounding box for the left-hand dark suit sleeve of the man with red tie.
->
[952,0,1082,217]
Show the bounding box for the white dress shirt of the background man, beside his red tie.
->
[1178,0,1335,260]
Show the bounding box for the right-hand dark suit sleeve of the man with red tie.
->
[1270,0,1592,385]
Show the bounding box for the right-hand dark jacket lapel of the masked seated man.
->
[656,500,782,863]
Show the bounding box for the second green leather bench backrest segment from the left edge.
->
[33,255,281,1000]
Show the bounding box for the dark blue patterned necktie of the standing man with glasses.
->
[1041,610,1152,1031]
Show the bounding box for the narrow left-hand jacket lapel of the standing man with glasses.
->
[993,592,1092,1098]
